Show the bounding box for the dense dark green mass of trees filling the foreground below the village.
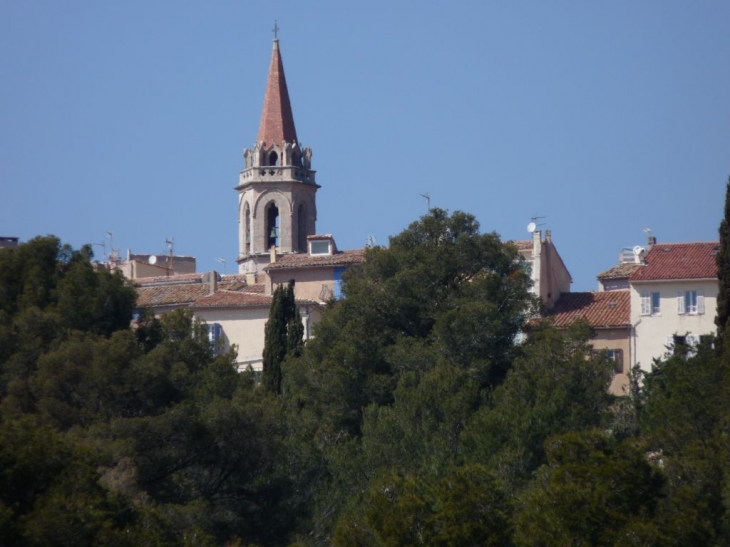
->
[0,210,730,547]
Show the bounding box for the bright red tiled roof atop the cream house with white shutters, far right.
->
[630,241,719,282]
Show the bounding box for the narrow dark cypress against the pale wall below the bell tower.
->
[263,281,304,393]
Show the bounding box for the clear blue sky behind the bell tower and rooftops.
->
[0,0,730,291]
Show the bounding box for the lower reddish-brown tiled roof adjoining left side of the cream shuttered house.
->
[547,290,631,328]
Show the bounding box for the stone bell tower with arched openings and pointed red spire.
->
[235,37,319,273]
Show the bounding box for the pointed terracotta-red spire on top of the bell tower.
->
[256,38,299,147]
